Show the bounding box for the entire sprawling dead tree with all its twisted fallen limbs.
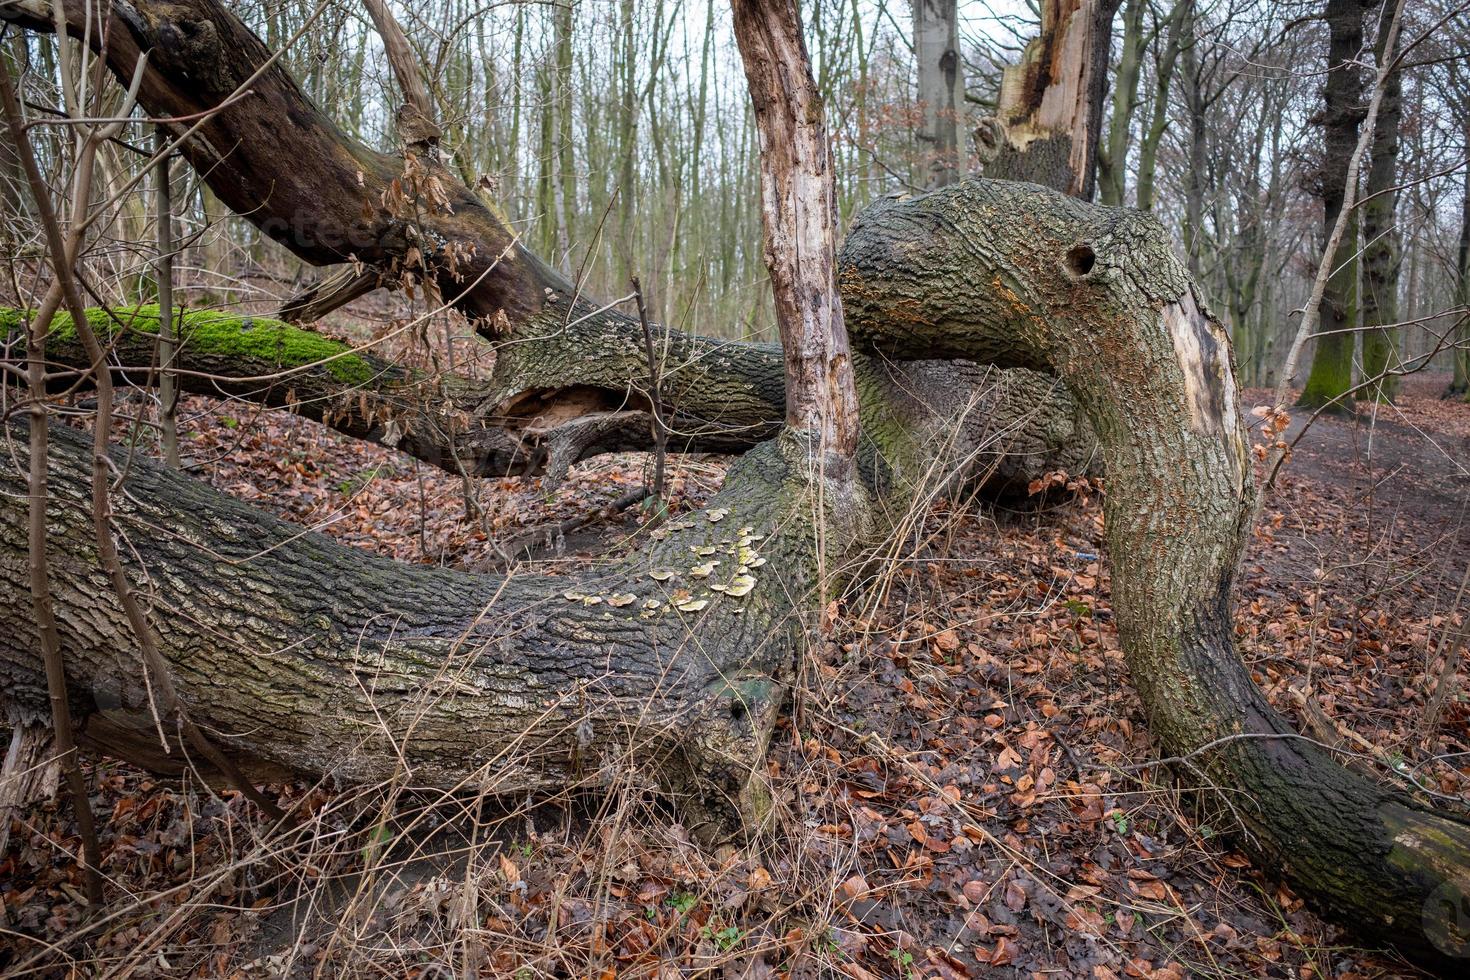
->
[0,0,1470,965]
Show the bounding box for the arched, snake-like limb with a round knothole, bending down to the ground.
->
[839,181,1470,965]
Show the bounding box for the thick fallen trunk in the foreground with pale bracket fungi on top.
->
[0,422,813,828]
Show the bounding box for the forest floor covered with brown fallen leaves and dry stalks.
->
[0,376,1470,980]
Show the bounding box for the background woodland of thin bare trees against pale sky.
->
[0,0,1470,386]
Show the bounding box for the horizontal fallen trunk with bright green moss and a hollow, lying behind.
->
[0,306,1100,497]
